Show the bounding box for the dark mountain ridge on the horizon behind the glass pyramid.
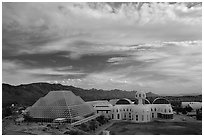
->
[2,83,157,107]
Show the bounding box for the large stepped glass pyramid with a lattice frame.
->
[29,91,95,119]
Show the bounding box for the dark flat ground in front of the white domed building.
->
[106,115,202,135]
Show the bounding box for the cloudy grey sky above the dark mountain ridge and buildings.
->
[2,2,202,94]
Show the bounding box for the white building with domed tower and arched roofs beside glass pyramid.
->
[92,91,173,123]
